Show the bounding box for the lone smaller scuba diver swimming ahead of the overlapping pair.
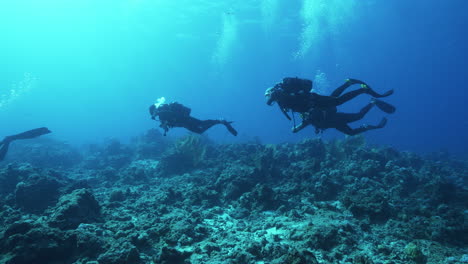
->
[149,97,237,136]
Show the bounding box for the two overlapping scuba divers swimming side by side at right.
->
[265,77,396,135]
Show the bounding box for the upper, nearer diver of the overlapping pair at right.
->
[265,77,393,120]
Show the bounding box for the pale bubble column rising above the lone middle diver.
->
[213,13,238,66]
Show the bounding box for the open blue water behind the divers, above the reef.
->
[0,0,468,155]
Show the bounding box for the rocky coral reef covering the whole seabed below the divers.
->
[0,133,468,264]
